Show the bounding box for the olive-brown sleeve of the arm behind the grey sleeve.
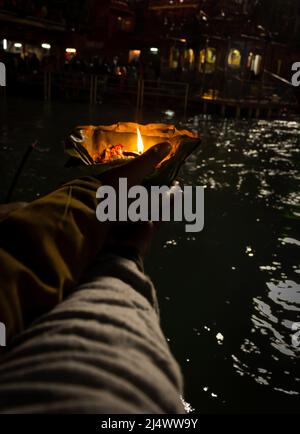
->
[0,178,107,339]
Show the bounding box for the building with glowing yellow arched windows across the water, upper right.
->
[144,0,300,86]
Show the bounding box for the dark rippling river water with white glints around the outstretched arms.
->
[0,101,300,413]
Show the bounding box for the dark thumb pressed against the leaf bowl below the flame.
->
[103,142,172,187]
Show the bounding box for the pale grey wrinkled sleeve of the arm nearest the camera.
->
[0,255,184,414]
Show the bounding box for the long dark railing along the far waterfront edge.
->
[2,71,297,114]
